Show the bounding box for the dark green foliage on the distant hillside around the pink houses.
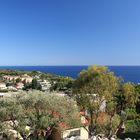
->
[0,69,74,93]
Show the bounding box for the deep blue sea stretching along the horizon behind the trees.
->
[0,66,140,84]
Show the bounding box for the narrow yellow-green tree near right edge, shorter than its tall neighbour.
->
[116,82,139,136]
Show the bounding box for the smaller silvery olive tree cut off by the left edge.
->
[0,97,25,137]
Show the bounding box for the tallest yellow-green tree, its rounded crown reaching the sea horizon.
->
[73,66,120,135]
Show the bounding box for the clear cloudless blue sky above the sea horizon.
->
[0,0,140,65]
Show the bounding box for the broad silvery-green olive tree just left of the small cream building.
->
[19,91,80,139]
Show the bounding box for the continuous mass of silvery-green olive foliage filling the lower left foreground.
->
[0,91,80,137]
